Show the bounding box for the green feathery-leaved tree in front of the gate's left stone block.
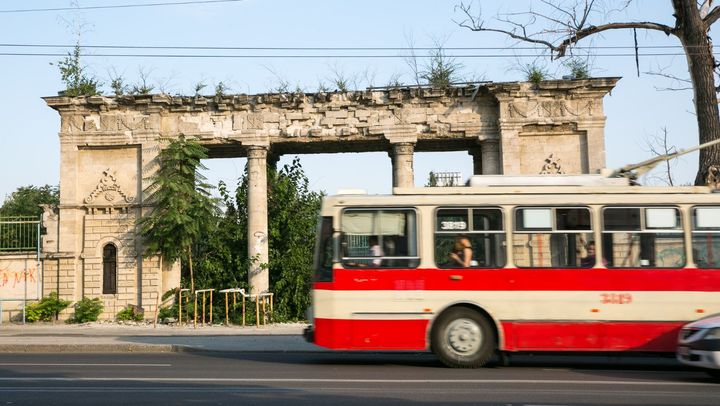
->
[138,135,218,292]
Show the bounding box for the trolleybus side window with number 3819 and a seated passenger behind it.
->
[435,208,505,268]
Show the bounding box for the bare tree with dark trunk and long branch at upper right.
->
[458,0,720,185]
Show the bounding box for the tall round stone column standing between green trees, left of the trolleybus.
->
[247,146,270,293]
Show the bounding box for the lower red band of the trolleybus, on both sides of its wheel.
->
[314,318,683,352]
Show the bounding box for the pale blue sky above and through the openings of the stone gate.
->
[0,0,697,200]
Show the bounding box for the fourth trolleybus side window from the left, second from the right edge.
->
[602,207,685,268]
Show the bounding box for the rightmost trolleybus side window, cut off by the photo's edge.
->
[692,206,720,268]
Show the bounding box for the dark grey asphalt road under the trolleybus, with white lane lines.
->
[0,353,720,406]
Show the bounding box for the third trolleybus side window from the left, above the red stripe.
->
[513,207,595,268]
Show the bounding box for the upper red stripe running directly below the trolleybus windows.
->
[313,268,720,292]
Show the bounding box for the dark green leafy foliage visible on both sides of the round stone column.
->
[196,158,322,320]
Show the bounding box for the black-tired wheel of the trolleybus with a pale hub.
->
[430,307,497,368]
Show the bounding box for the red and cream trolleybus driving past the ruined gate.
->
[306,175,720,367]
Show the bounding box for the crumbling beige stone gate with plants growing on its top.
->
[43,78,618,316]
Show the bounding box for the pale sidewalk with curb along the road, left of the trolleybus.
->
[0,322,323,353]
